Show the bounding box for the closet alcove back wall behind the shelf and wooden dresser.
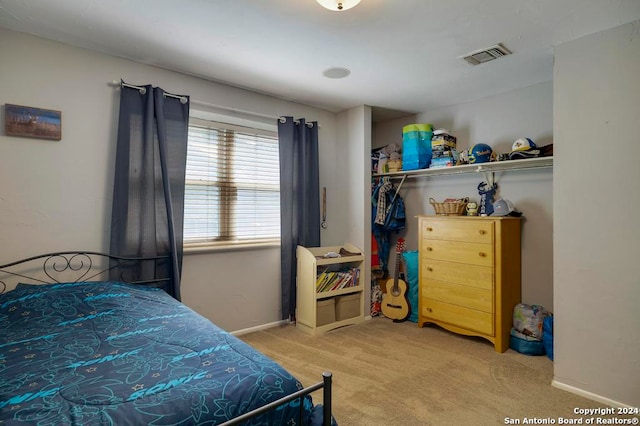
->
[374,82,553,310]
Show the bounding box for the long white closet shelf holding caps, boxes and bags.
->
[373,157,553,179]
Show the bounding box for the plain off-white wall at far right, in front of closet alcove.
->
[553,21,640,407]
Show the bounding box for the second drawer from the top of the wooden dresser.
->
[420,240,493,267]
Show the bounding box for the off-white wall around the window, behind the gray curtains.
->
[0,29,340,331]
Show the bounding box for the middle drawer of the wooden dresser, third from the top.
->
[420,258,493,290]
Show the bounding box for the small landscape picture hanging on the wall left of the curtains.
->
[4,104,62,141]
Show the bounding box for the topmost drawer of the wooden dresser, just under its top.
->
[420,218,494,244]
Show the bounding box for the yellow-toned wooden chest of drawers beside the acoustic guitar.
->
[418,216,521,352]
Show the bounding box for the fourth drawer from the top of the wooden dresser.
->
[422,280,493,314]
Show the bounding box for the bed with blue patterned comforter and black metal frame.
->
[0,252,335,426]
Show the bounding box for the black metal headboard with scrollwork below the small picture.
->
[0,251,171,293]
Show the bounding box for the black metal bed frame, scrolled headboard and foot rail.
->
[0,251,333,426]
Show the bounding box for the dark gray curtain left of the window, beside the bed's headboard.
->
[110,85,189,300]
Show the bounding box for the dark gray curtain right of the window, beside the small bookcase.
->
[278,117,320,320]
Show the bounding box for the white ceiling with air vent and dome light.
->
[0,0,640,117]
